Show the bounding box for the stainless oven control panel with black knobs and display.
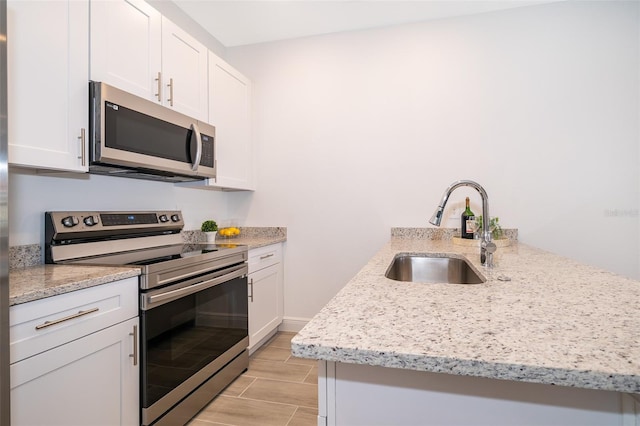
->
[45,210,184,240]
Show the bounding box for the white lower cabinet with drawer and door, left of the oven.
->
[10,278,140,426]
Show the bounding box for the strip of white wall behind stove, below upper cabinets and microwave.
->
[9,172,232,246]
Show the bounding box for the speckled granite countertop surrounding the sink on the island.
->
[291,237,640,393]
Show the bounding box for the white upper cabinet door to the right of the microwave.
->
[209,52,253,189]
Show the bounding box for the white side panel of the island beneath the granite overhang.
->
[318,361,639,426]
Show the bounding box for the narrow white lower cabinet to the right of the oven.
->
[249,244,284,352]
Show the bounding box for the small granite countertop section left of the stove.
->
[9,265,140,305]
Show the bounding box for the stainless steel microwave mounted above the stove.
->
[89,81,216,182]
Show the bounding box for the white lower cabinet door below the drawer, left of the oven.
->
[10,318,140,426]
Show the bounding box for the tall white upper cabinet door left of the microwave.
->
[7,0,89,171]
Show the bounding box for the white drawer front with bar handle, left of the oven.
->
[9,277,138,363]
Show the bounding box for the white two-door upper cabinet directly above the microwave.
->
[90,0,208,121]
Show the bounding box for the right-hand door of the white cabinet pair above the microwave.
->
[162,18,208,122]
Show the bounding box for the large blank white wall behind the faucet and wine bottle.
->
[227,2,640,318]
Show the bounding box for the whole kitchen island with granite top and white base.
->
[292,233,640,425]
